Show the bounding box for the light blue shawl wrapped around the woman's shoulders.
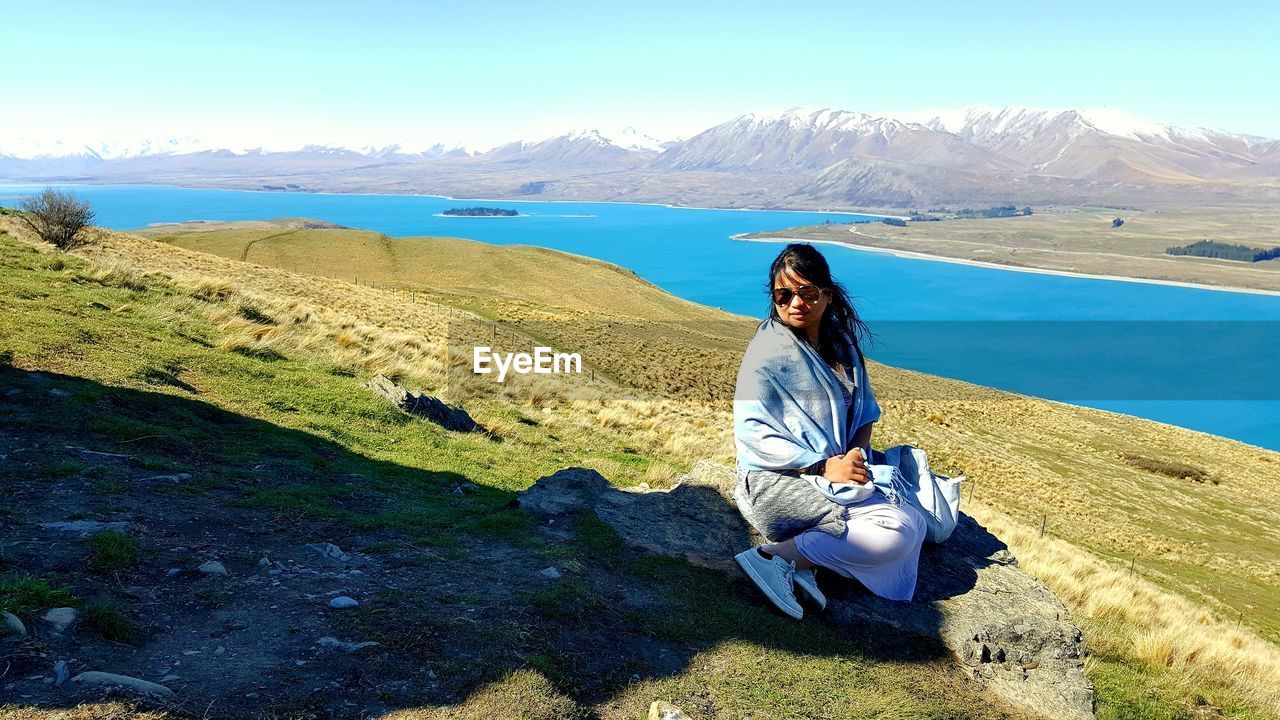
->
[733,316,879,471]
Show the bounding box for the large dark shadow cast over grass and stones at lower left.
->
[0,366,988,717]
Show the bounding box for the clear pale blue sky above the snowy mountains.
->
[0,0,1280,149]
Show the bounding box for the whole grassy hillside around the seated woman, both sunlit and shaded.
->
[0,219,1280,717]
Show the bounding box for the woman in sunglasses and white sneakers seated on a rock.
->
[733,243,925,619]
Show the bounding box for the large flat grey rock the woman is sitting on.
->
[518,461,1094,720]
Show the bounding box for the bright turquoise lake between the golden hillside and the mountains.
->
[0,180,1280,450]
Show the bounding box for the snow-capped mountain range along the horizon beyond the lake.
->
[0,106,1280,208]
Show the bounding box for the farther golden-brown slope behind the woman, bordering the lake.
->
[140,219,1280,641]
